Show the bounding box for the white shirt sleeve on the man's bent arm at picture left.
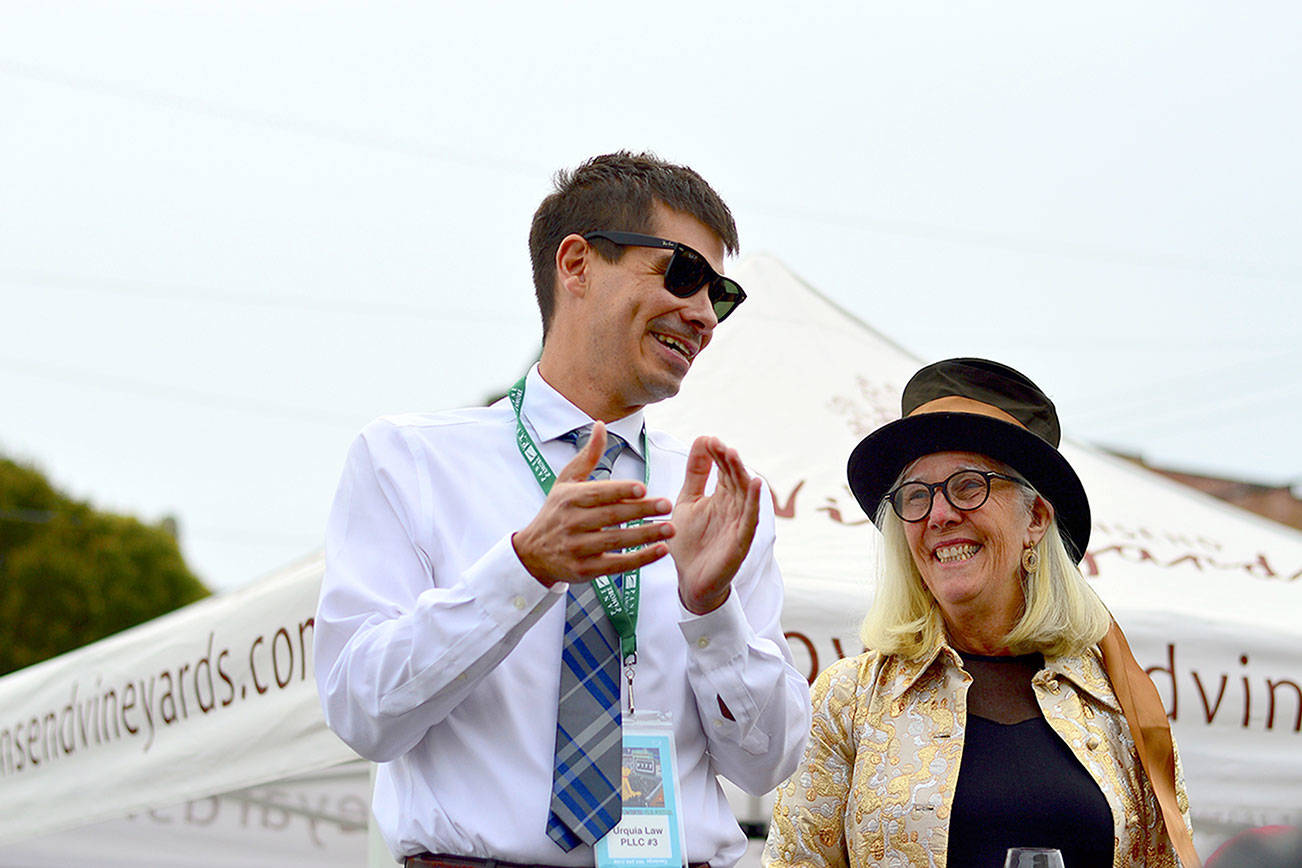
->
[315,420,565,761]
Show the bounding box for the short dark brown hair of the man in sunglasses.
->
[529,151,738,340]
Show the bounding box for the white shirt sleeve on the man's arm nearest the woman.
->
[678,487,810,795]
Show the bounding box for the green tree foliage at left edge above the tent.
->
[0,458,210,675]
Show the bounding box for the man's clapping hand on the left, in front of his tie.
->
[510,422,673,587]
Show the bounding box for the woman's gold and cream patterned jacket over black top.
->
[763,645,1189,868]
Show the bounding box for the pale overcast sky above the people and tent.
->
[0,0,1302,590]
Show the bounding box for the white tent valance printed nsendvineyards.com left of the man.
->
[0,558,354,843]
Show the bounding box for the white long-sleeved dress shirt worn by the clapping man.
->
[315,366,810,865]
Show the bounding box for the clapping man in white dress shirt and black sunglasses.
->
[315,152,809,867]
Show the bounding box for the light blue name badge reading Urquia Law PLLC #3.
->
[596,712,687,868]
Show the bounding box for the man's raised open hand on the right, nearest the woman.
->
[667,437,760,614]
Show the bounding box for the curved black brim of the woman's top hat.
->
[846,413,1090,561]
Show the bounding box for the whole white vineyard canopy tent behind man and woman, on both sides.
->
[0,258,1302,865]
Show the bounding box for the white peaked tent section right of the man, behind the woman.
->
[648,258,1302,841]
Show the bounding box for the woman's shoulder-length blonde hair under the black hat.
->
[859,472,1112,660]
